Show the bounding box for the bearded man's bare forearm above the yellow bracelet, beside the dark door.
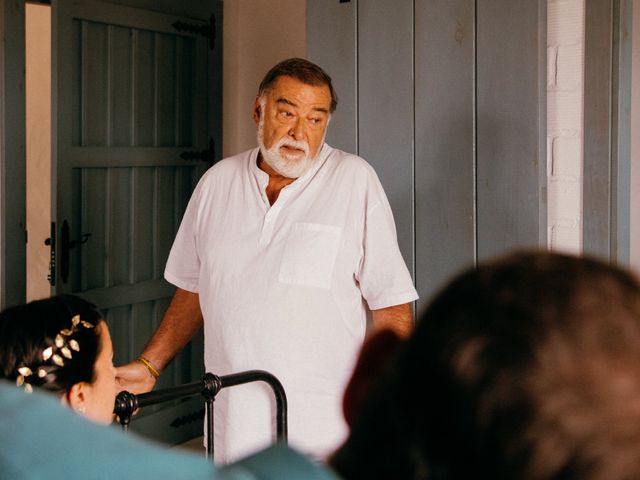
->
[142,288,202,370]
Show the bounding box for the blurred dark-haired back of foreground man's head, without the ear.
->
[333,253,640,480]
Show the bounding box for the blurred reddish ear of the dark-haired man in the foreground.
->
[342,329,404,427]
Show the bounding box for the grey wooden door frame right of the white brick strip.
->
[582,0,637,265]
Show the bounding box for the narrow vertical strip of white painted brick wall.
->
[547,0,584,253]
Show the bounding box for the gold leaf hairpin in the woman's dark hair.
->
[16,315,95,393]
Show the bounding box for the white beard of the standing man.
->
[258,105,314,178]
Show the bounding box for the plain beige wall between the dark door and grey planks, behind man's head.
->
[222,0,306,157]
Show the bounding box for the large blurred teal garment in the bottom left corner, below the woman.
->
[0,382,218,480]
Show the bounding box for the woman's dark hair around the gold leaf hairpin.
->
[0,295,102,394]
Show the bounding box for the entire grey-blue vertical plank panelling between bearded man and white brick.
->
[307,0,546,307]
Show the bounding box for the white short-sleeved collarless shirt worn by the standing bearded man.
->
[165,144,418,463]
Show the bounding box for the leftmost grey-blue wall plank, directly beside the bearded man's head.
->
[307,0,358,153]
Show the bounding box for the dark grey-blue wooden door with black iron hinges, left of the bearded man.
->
[52,1,214,443]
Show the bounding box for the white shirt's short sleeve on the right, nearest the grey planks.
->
[356,177,418,310]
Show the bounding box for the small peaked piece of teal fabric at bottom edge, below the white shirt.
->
[221,444,338,480]
